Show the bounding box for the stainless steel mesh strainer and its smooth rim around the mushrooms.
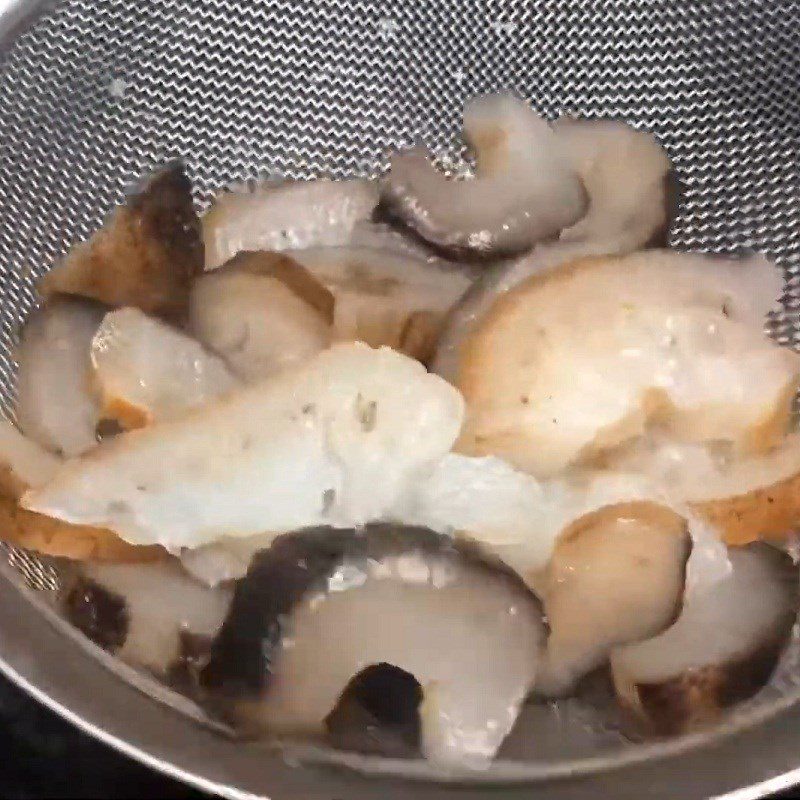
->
[0,0,800,800]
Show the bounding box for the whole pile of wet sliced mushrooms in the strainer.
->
[0,96,800,768]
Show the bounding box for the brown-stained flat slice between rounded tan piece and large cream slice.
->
[292,247,472,362]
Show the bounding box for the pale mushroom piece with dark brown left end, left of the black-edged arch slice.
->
[66,561,232,674]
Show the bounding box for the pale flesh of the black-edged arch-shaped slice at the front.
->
[263,556,544,766]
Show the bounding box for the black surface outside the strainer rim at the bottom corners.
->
[0,677,800,800]
